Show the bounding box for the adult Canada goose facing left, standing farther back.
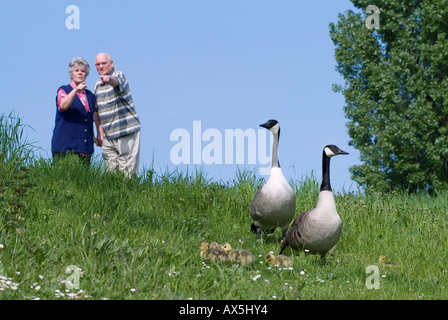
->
[249,120,296,240]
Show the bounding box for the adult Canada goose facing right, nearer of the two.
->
[280,145,348,262]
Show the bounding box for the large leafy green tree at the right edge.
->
[330,0,448,192]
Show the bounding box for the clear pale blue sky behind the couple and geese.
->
[0,0,359,191]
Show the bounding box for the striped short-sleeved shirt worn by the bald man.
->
[93,70,140,139]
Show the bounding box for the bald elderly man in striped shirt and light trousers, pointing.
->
[93,53,140,177]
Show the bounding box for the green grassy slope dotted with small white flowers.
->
[0,113,448,300]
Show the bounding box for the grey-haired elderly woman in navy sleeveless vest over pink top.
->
[51,57,104,163]
